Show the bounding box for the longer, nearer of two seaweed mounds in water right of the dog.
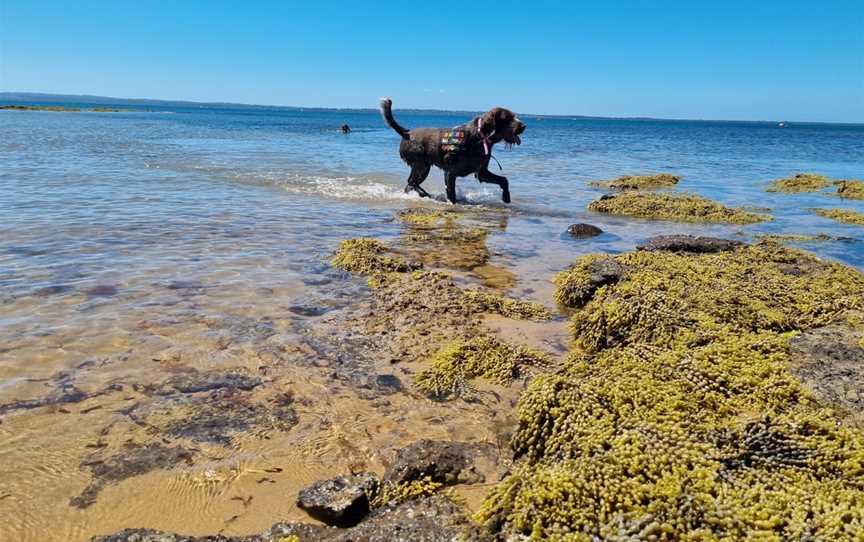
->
[588,192,772,224]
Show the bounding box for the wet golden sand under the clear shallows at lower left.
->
[0,205,567,541]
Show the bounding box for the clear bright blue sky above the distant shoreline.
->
[0,0,864,122]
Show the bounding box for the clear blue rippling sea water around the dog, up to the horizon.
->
[0,102,864,538]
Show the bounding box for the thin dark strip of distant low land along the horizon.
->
[0,92,864,126]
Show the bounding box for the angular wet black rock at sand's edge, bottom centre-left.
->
[297,473,378,527]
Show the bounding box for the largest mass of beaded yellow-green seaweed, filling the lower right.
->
[477,243,864,541]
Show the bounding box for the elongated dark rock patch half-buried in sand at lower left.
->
[69,443,192,508]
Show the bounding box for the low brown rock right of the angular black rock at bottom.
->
[384,439,485,485]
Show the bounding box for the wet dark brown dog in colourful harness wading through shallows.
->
[381,98,526,203]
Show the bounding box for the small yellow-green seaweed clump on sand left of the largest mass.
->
[415,335,551,400]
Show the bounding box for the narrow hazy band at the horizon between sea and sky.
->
[0,91,864,126]
